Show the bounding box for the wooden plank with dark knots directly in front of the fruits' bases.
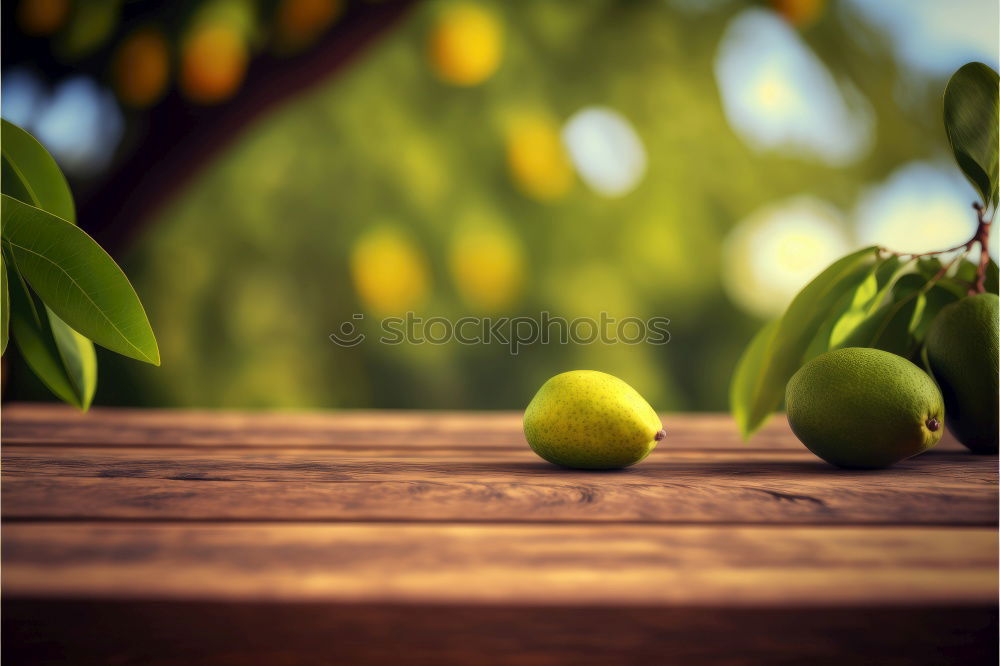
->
[2,448,997,525]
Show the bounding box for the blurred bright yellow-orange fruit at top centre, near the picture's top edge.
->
[430,3,503,86]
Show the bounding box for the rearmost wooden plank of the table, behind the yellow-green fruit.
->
[2,403,961,450]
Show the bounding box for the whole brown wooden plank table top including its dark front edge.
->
[2,404,998,664]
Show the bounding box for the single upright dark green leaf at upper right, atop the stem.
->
[944,62,1000,207]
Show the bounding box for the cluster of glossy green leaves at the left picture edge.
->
[0,120,160,409]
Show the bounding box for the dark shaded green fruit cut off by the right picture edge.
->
[926,294,1000,453]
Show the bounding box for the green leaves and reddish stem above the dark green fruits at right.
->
[729,63,1000,437]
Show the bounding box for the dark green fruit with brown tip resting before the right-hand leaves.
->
[785,347,944,469]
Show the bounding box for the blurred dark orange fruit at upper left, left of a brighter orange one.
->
[112,28,170,107]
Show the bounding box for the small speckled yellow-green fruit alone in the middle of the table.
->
[524,370,666,469]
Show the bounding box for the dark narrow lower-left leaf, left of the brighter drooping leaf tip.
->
[4,248,84,409]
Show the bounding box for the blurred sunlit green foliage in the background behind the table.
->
[99,0,960,410]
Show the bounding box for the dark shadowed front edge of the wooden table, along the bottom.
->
[3,599,997,666]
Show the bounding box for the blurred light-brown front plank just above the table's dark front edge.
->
[3,523,997,607]
